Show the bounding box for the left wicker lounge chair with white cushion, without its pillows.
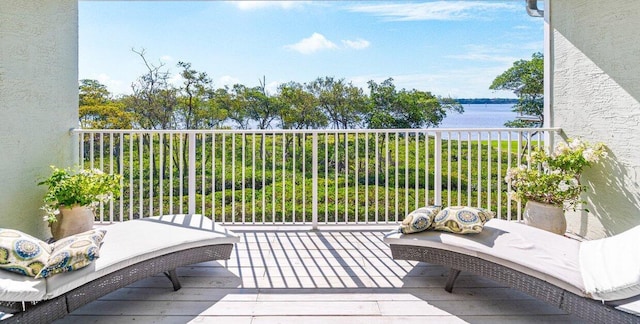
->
[0,215,239,323]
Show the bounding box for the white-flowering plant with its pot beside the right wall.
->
[505,139,607,234]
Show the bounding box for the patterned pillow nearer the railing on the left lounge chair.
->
[36,229,107,278]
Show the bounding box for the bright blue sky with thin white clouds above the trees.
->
[79,0,543,98]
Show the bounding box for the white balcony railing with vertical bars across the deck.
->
[72,128,559,227]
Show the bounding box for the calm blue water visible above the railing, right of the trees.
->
[438,104,517,128]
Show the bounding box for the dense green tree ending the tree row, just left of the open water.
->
[366,78,464,128]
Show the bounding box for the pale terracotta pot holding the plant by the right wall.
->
[523,201,567,235]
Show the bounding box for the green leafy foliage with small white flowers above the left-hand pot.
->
[38,166,120,223]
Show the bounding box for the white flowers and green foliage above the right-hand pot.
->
[505,139,607,210]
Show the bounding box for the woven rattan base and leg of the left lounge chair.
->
[2,244,233,324]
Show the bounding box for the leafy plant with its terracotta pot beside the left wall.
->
[38,166,120,240]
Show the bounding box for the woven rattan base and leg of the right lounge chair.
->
[390,244,640,323]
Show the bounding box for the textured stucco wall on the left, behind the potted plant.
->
[0,0,78,238]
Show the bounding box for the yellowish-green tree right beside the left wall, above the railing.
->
[78,79,132,129]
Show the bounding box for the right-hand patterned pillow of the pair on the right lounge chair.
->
[433,206,494,234]
